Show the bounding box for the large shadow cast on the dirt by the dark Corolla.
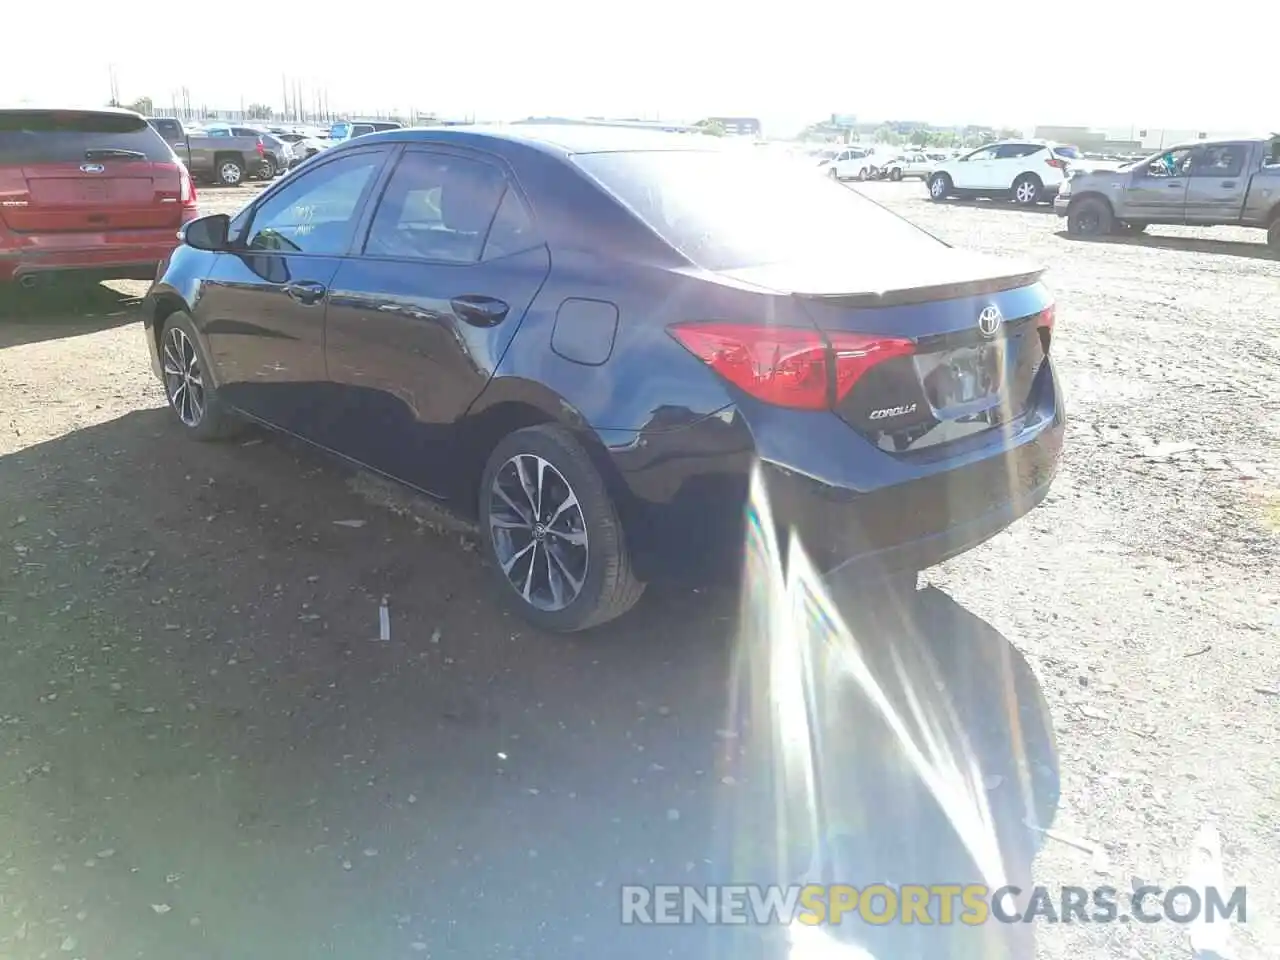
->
[0,410,1057,960]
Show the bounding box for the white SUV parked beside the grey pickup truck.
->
[928,140,1080,206]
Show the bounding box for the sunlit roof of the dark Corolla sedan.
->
[350,123,723,156]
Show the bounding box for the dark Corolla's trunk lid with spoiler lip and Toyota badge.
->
[730,252,1053,453]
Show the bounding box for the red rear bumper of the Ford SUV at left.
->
[0,224,189,283]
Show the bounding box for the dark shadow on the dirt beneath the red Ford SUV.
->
[0,283,141,349]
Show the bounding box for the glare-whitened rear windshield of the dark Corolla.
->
[573,151,940,270]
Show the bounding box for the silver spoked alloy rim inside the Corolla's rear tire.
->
[489,453,590,612]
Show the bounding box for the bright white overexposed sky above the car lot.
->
[0,0,1280,133]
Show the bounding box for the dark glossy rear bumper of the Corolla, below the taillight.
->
[604,364,1065,580]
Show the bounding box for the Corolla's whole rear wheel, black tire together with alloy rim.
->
[479,424,645,634]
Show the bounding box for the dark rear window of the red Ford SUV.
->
[0,110,174,164]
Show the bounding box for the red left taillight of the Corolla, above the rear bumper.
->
[671,324,915,410]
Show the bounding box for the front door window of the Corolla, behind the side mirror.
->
[240,151,383,256]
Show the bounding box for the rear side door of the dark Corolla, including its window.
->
[325,147,550,497]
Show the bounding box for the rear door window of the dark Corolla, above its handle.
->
[365,150,507,264]
